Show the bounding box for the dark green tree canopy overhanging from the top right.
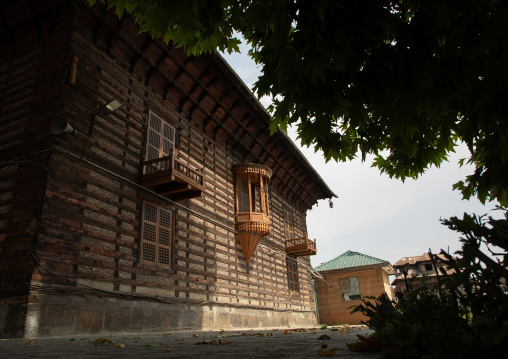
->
[87,0,508,205]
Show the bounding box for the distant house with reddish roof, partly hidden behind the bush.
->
[392,253,452,292]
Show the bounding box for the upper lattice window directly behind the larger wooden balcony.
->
[146,111,176,160]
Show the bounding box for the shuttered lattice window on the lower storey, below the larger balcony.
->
[141,202,171,266]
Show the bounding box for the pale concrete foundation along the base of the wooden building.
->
[4,294,317,338]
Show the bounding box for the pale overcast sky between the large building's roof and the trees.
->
[223,47,501,267]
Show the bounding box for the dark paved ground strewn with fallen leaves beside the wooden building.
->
[0,326,384,359]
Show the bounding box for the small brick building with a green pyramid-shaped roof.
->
[316,251,395,325]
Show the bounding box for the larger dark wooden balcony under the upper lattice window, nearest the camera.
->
[140,152,205,201]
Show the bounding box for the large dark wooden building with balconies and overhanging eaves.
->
[0,0,334,337]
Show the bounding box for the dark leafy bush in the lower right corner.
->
[353,209,508,358]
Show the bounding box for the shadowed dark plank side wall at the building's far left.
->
[0,1,72,316]
